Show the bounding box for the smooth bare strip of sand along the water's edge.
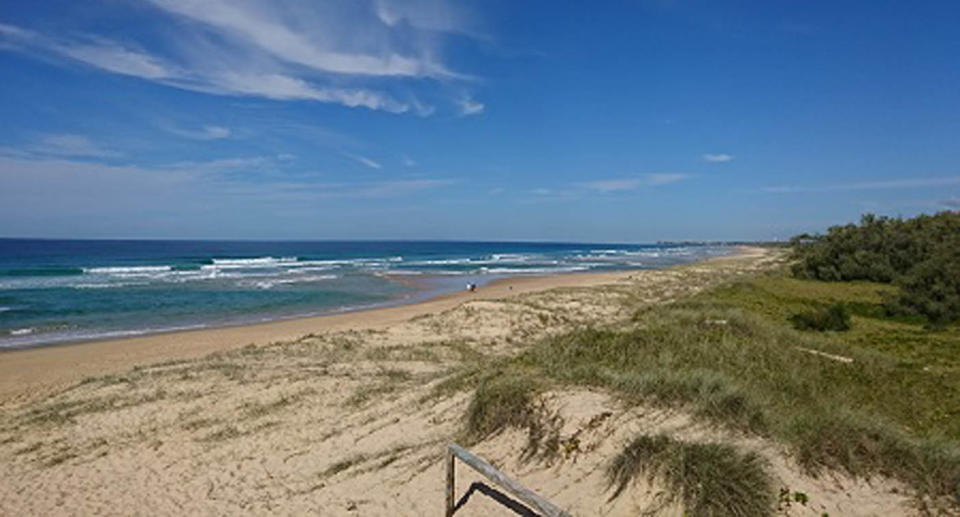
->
[0,246,764,407]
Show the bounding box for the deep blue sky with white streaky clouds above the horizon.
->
[0,0,960,242]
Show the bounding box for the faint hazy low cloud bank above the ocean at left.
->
[0,155,453,216]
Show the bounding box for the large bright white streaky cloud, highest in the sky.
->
[0,0,483,116]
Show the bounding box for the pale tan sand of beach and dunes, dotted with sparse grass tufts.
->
[0,250,911,516]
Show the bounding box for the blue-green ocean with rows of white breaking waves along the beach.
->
[0,239,731,348]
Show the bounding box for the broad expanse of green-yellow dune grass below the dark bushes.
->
[450,273,960,514]
